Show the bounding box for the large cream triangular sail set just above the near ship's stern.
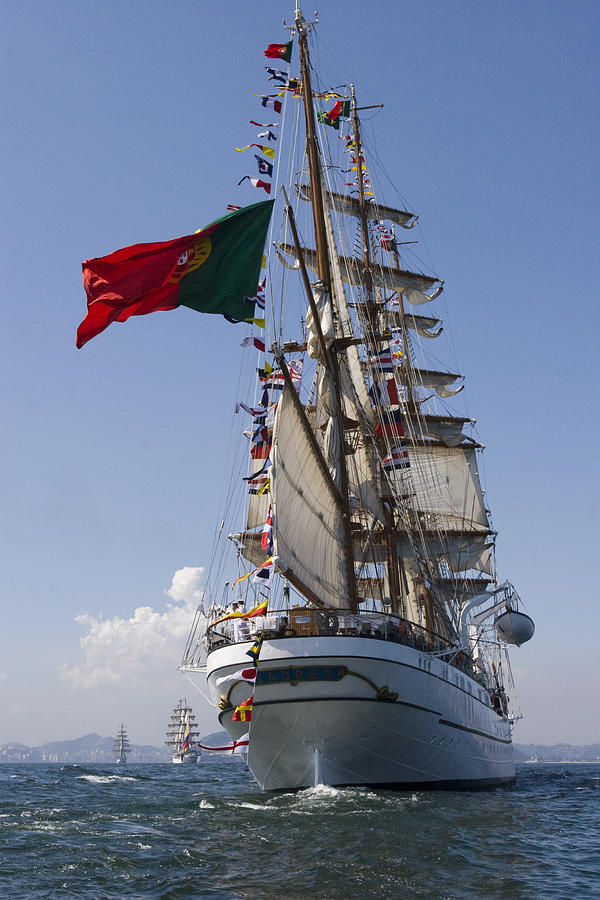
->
[271,386,348,608]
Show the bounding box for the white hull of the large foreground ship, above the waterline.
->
[207,636,515,790]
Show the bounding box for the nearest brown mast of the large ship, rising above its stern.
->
[295,7,358,612]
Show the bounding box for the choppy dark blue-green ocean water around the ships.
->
[0,756,600,900]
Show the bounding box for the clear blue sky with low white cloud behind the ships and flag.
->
[0,0,600,745]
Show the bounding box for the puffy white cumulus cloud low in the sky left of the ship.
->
[59,566,204,688]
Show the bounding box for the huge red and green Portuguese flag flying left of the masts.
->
[77,200,274,347]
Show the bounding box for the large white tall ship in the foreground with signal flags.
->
[181,8,534,790]
